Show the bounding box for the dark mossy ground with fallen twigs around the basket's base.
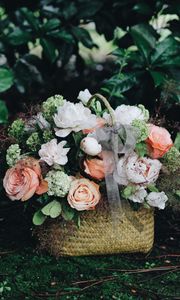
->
[0,207,180,300]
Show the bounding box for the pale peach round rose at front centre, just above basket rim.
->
[67,178,101,211]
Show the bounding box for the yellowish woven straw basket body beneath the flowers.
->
[36,201,154,257]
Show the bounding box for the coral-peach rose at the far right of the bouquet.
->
[146,124,173,158]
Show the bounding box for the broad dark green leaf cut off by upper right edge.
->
[151,36,180,65]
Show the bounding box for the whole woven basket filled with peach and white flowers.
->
[3,90,179,255]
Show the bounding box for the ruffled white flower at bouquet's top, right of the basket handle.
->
[103,104,147,125]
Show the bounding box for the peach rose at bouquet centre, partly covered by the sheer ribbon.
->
[84,151,114,180]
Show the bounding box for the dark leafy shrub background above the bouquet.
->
[0,0,180,125]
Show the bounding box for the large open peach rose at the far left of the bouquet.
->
[3,157,48,201]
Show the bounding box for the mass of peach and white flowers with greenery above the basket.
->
[3,89,173,225]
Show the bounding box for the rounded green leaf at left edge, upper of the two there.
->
[0,68,14,93]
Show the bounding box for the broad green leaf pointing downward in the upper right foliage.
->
[130,24,157,61]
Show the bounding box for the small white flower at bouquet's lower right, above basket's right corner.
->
[146,192,168,209]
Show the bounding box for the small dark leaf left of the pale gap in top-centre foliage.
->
[72,26,95,49]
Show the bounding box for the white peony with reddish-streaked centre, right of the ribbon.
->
[114,152,162,186]
